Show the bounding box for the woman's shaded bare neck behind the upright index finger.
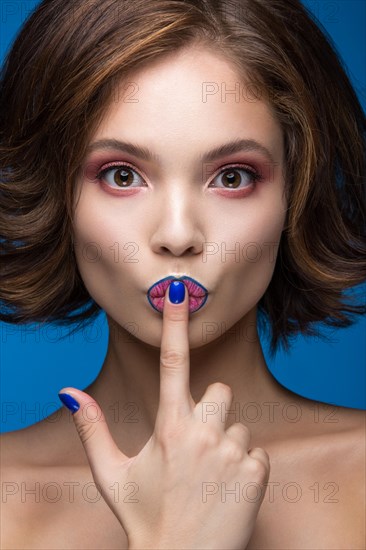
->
[85,308,293,456]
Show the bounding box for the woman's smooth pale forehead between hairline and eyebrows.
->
[93,46,282,166]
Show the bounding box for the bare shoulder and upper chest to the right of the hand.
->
[256,399,366,550]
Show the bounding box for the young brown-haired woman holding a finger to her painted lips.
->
[0,0,366,549]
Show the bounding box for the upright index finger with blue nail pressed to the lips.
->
[157,281,195,432]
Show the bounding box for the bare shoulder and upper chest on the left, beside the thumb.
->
[0,421,127,550]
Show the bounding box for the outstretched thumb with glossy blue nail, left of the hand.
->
[58,387,126,479]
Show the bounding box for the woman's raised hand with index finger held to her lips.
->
[60,282,270,550]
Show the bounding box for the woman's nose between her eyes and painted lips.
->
[150,183,205,256]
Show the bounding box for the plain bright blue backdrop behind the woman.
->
[0,0,366,432]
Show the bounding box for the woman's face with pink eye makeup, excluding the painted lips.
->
[74,48,287,349]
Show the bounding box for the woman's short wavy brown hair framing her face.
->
[0,0,366,355]
